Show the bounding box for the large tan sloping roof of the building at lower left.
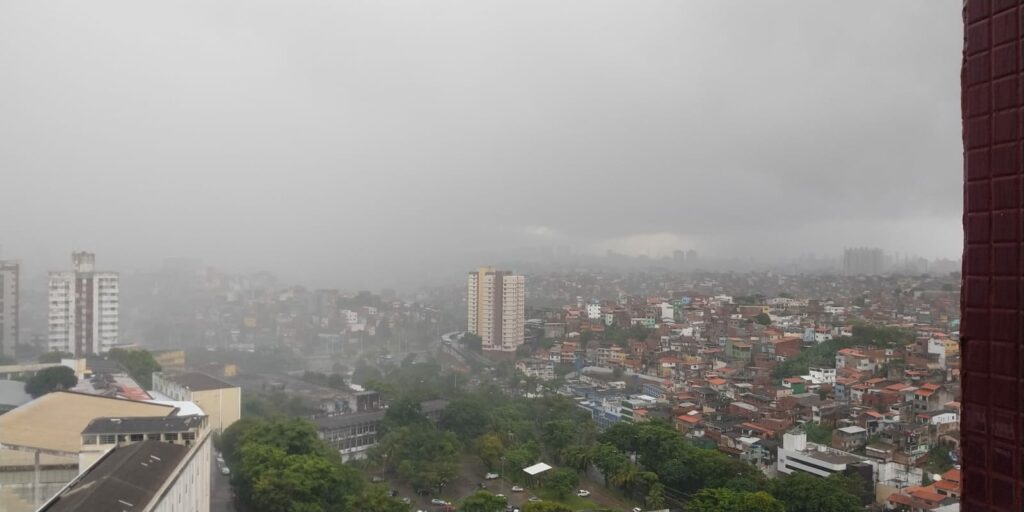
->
[0,391,174,454]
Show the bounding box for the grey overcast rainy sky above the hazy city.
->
[0,0,963,286]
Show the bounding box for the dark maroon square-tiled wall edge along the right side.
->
[961,0,1024,512]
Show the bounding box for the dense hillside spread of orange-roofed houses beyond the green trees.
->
[516,278,961,511]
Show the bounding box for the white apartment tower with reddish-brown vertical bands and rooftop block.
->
[48,252,120,356]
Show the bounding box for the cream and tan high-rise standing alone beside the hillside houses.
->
[466,267,526,352]
